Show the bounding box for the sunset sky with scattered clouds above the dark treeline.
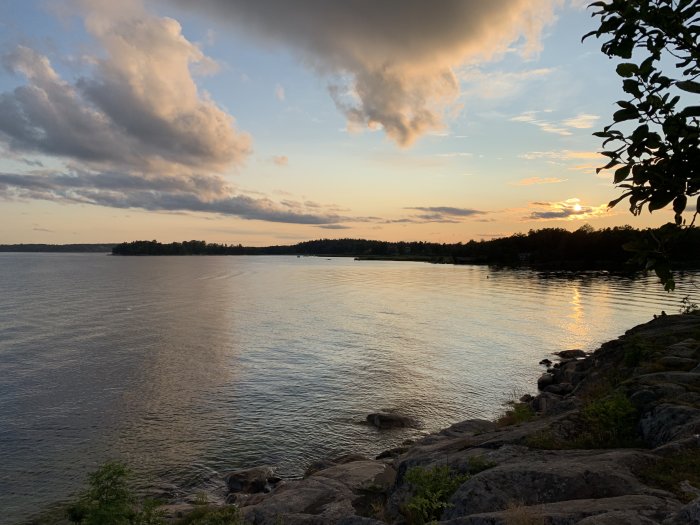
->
[0,0,672,246]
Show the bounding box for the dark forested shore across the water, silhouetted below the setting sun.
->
[112,225,700,269]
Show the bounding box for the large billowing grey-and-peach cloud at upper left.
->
[0,2,250,173]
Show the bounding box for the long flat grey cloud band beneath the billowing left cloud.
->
[0,172,352,225]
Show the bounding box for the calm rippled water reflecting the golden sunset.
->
[0,254,697,522]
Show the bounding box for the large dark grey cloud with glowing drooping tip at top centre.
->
[171,0,560,146]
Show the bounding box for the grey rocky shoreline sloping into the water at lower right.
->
[167,312,700,525]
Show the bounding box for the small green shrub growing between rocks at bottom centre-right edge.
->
[405,465,469,524]
